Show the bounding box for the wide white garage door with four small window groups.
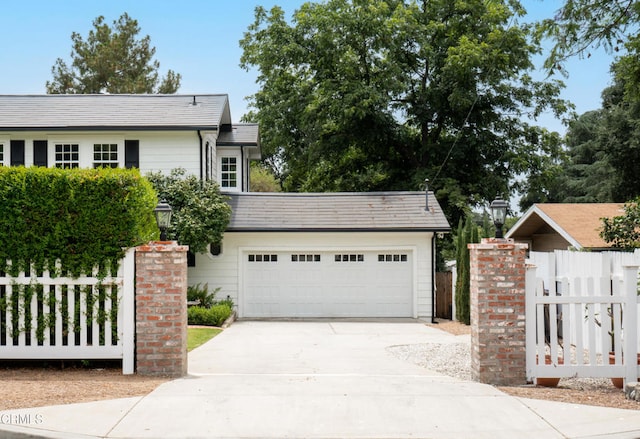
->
[241,250,413,317]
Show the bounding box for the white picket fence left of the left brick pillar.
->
[0,249,135,374]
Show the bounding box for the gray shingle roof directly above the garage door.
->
[227,192,450,232]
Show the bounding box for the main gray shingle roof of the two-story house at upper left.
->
[0,94,231,131]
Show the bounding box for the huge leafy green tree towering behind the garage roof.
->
[240,0,570,222]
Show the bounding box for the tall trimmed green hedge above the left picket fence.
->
[0,167,158,275]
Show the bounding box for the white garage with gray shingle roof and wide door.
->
[189,192,449,319]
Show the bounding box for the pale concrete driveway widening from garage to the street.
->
[0,321,640,439]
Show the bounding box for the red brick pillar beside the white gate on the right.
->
[469,238,527,385]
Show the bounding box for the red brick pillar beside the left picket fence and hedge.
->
[136,241,188,377]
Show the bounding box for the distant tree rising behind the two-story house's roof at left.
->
[46,13,181,94]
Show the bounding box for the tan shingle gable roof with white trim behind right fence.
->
[506,203,624,249]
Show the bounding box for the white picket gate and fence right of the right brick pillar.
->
[526,251,640,382]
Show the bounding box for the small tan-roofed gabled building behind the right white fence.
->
[505,203,624,252]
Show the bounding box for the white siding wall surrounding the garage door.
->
[189,232,433,318]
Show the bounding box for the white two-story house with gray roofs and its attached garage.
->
[0,95,450,318]
